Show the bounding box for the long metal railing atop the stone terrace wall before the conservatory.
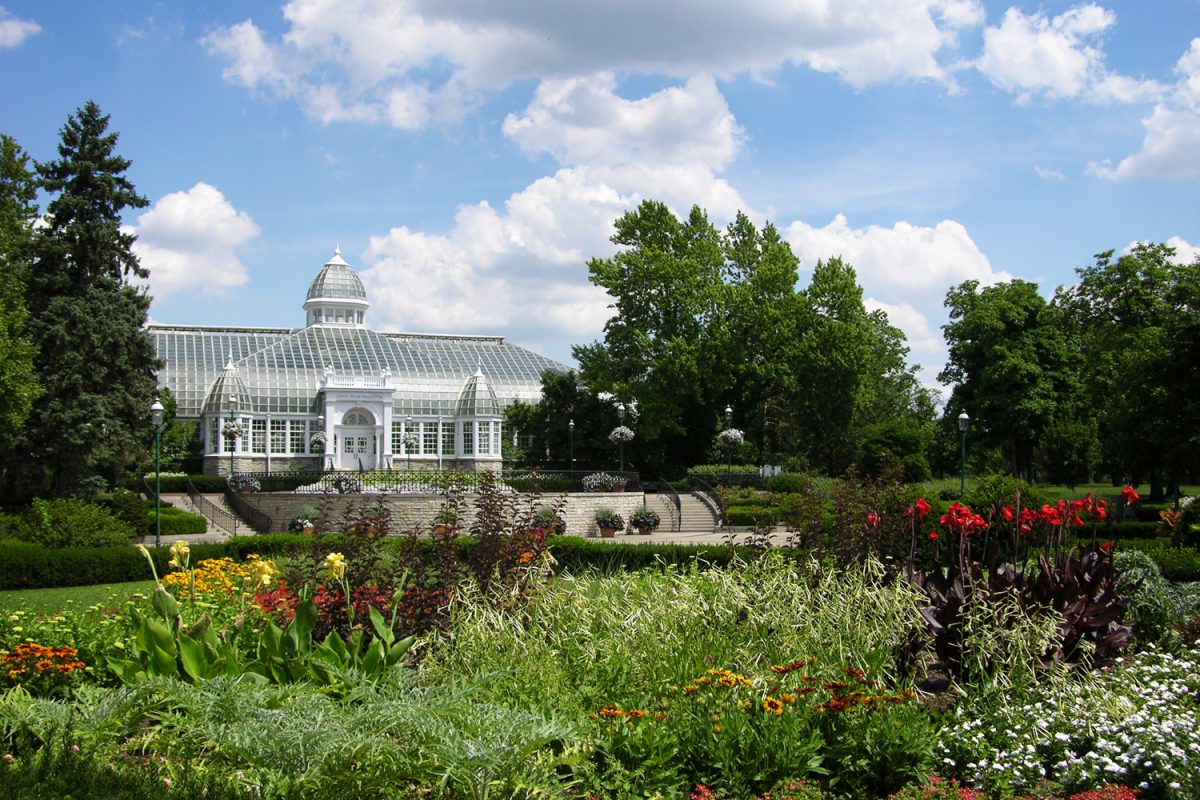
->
[223,469,642,494]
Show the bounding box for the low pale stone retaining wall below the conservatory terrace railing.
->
[241,492,646,536]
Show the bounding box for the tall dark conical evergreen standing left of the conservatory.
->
[10,101,158,497]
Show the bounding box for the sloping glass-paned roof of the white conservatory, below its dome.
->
[149,325,566,419]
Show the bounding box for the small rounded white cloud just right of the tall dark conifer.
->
[130,182,259,297]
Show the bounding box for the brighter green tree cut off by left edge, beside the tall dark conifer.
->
[0,136,38,463]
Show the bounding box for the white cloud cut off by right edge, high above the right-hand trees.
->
[1088,37,1200,180]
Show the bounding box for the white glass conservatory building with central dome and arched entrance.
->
[149,251,566,475]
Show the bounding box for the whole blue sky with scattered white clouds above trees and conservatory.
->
[0,0,1200,400]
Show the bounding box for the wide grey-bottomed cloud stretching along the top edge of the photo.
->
[202,0,983,128]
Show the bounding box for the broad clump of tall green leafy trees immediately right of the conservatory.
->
[564,200,932,476]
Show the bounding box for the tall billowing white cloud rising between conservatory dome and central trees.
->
[362,74,748,343]
